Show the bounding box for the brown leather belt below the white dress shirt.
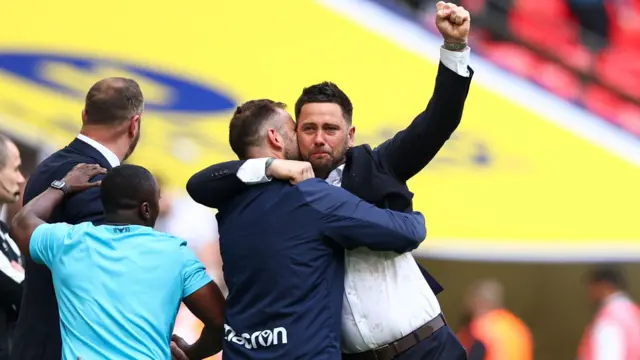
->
[342,314,447,360]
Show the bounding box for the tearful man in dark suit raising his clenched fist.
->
[187,2,473,360]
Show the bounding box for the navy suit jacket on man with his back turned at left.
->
[11,139,111,360]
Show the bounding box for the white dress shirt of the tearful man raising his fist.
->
[237,49,469,353]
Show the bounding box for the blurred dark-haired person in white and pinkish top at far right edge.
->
[578,266,640,360]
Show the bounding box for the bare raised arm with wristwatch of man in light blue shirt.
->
[12,164,106,256]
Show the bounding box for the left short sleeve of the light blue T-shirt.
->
[29,223,72,268]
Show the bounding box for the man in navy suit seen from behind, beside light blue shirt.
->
[11,78,144,360]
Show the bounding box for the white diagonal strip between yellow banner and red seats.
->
[316,0,640,167]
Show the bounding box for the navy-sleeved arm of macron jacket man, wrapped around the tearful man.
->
[296,179,426,253]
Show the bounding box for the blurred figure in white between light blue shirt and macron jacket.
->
[155,176,227,358]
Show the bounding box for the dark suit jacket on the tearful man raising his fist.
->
[187,63,473,294]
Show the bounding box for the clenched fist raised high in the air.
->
[436,1,471,44]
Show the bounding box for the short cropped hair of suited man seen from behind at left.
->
[84,77,144,125]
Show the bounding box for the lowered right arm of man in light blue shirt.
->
[171,281,225,360]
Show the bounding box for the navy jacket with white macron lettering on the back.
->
[218,179,426,360]
